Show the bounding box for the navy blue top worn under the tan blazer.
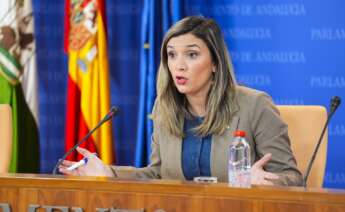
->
[182,117,212,180]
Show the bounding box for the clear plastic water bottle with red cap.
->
[228,130,251,188]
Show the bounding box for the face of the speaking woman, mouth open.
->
[167,33,215,97]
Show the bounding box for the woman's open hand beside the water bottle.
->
[250,153,279,185]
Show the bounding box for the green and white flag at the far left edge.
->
[0,0,40,173]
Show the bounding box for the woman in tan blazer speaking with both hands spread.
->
[60,17,302,185]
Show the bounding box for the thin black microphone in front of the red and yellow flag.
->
[53,106,119,175]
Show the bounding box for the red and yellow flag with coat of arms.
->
[65,0,113,164]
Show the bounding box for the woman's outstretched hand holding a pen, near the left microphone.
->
[59,147,114,177]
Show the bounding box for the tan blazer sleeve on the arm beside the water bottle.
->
[251,93,303,186]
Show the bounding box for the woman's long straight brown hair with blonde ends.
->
[152,16,236,138]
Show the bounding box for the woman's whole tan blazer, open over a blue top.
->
[112,86,302,186]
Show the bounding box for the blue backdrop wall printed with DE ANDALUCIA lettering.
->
[34,0,345,188]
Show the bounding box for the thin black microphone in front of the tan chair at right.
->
[303,96,341,187]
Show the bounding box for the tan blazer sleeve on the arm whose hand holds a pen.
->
[111,133,161,179]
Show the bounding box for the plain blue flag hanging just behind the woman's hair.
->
[135,0,183,167]
